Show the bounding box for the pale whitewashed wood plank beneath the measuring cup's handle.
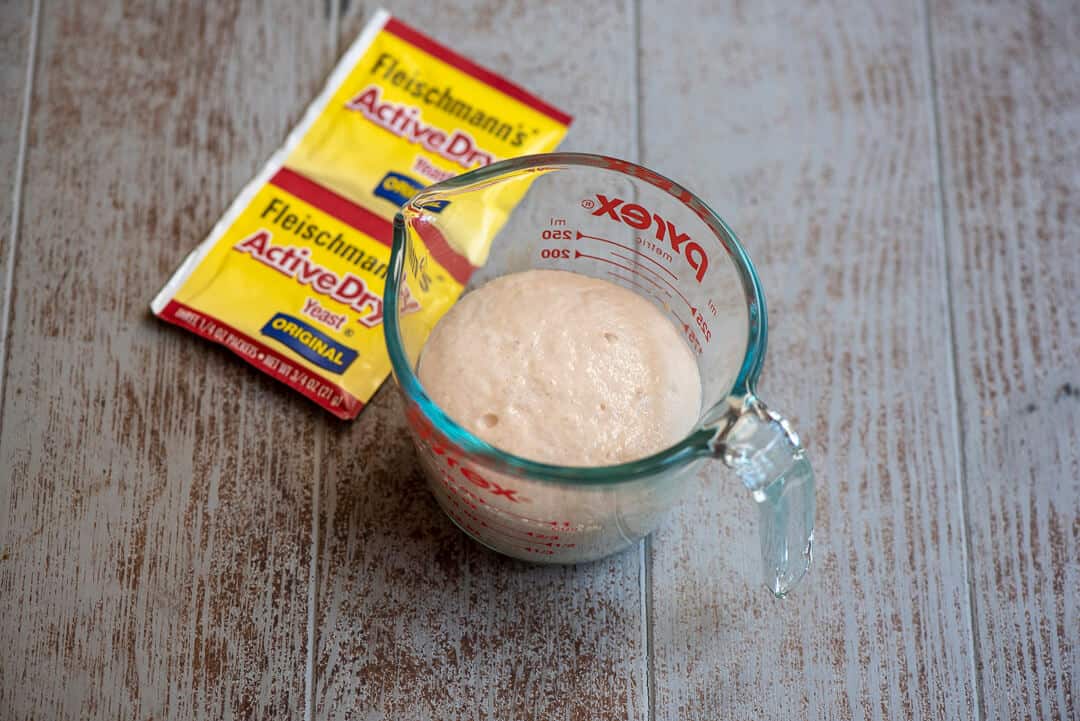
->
[642,0,976,721]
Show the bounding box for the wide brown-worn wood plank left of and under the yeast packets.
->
[0,0,333,720]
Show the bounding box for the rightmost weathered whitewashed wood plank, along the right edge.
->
[931,1,1080,721]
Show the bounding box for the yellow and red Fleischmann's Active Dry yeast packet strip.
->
[151,11,571,418]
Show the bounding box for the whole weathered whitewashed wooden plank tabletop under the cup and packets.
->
[0,0,1080,721]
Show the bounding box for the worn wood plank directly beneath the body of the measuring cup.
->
[316,2,647,720]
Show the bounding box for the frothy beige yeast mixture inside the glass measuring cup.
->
[419,270,701,466]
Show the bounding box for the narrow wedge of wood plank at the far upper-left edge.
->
[0,0,35,399]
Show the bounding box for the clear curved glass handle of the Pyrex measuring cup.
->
[711,395,814,598]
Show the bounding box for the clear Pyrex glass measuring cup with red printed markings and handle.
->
[383,153,814,597]
